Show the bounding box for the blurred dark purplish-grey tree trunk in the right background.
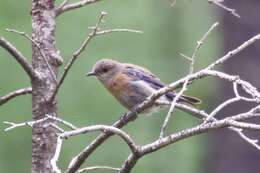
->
[208,0,260,173]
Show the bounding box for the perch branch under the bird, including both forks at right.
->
[65,34,260,173]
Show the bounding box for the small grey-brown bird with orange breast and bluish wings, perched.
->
[87,59,200,112]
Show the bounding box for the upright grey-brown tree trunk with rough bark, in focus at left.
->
[31,0,61,173]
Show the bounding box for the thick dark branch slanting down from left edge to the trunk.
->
[0,37,39,79]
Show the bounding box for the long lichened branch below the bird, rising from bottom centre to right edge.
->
[119,107,260,173]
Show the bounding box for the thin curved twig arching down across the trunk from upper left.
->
[6,28,57,82]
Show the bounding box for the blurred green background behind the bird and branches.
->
[0,0,220,173]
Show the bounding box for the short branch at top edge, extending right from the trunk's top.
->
[56,0,104,16]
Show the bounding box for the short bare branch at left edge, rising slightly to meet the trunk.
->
[0,87,32,105]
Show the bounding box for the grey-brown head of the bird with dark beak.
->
[86,59,123,84]
